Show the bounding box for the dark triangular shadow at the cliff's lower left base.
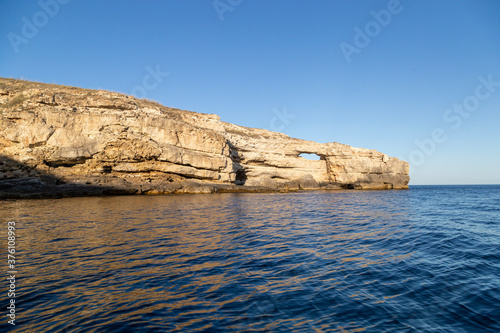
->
[0,155,133,200]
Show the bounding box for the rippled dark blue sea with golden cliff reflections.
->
[0,185,500,333]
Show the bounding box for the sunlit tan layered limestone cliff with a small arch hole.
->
[0,79,409,194]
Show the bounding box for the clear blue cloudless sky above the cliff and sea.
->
[0,0,500,185]
